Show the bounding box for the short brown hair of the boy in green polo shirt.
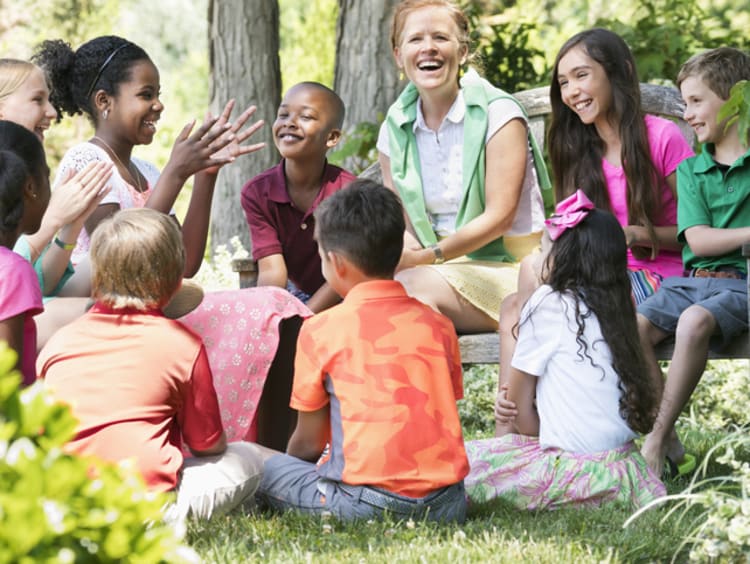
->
[677,47,750,100]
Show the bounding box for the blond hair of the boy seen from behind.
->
[90,208,185,311]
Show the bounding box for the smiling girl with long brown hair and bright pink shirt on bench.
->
[495,28,693,436]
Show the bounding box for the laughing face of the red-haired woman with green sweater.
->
[393,6,468,96]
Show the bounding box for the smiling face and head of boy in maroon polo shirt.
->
[272,85,341,159]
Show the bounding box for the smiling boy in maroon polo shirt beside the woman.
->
[242,82,355,313]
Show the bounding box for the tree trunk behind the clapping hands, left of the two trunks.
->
[208,0,281,251]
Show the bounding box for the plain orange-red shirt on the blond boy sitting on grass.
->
[37,304,223,490]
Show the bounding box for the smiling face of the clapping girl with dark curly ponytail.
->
[104,59,164,145]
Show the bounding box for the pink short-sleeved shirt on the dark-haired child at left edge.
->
[0,247,44,386]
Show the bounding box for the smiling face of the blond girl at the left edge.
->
[0,67,57,141]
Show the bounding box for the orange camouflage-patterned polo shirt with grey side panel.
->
[291,280,469,497]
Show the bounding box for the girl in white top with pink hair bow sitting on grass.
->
[465,190,665,509]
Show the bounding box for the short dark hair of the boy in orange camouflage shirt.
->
[314,178,406,278]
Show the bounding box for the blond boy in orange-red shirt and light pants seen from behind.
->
[37,208,262,519]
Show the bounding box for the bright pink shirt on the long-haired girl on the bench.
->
[602,115,693,277]
